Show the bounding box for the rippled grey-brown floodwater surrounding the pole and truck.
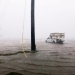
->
[0,40,75,75]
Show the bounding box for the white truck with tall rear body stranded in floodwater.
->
[46,33,65,43]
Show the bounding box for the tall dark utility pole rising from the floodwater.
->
[31,0,36,51]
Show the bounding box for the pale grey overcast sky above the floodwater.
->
[0,0,75,39]
